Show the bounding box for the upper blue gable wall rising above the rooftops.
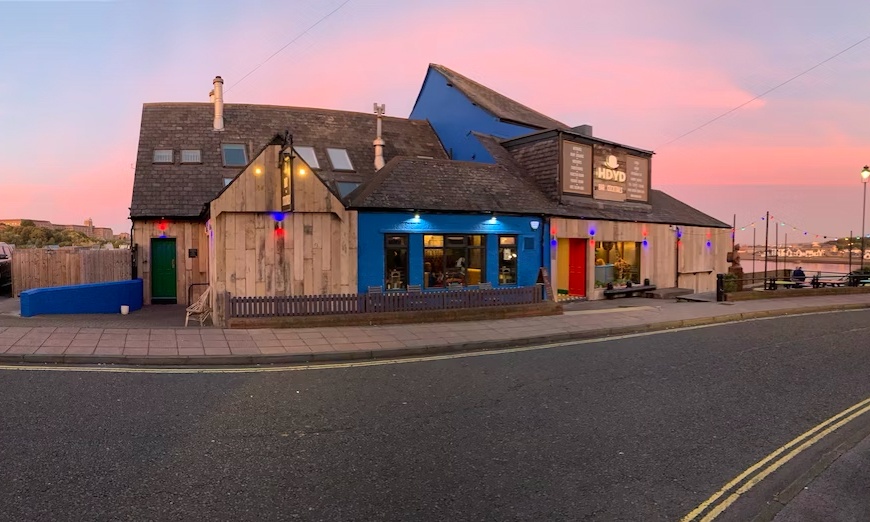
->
[410,69,537,163]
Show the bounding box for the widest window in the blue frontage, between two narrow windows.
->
[423,235,486,288]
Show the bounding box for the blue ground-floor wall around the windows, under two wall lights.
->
[358,212,550,293]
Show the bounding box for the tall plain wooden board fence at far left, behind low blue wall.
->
[12,248,132,296]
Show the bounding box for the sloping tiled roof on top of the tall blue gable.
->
[429,63,569,129]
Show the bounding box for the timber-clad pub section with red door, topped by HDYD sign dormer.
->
[501,125,731,299]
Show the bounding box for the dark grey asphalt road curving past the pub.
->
[0,311,870,521]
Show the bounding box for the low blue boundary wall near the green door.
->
[21,279,143,317]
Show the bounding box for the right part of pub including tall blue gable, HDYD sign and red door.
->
[410,64,732,299]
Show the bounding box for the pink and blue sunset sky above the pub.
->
[0,0,870,246]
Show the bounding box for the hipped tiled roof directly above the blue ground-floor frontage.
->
[348,158,553,214]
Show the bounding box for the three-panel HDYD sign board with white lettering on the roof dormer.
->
[561,140,649,202]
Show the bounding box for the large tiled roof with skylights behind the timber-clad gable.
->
[130,103,447,218]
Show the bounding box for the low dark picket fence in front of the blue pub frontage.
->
[227,285,543,318]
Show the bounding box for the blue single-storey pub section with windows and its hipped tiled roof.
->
[347,154,552,293]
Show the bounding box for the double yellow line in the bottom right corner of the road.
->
[680,398,870,522]
